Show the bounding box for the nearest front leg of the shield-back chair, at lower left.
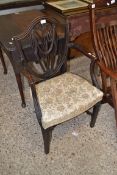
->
[40,124,53,154]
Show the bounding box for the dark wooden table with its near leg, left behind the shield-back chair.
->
[0,10,43,107]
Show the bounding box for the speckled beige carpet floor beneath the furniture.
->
[0,54,117,175]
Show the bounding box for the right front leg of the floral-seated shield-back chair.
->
[90,102,101,128]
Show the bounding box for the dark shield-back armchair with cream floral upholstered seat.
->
[14,17,103,154]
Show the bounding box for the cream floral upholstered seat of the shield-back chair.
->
[36,73,103,129]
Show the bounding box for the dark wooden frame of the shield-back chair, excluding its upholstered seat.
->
[14,17,101,154]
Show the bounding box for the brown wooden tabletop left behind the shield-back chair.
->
[0,10,44,51]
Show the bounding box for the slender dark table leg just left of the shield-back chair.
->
[15,73,26,108]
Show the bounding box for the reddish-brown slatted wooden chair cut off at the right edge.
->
[89,0,117,124]
